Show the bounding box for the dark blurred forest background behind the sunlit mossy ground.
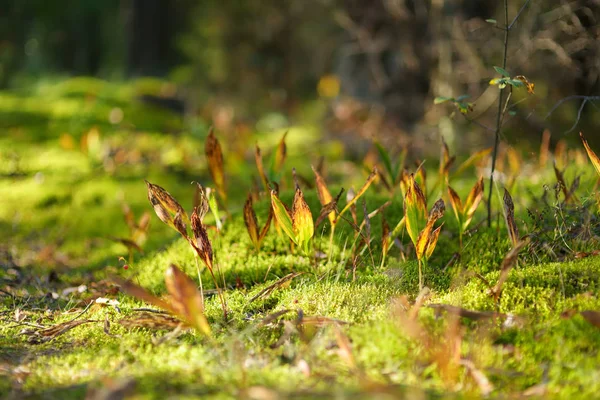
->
[0,0,600,156]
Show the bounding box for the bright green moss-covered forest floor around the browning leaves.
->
[0,79,600,399]
